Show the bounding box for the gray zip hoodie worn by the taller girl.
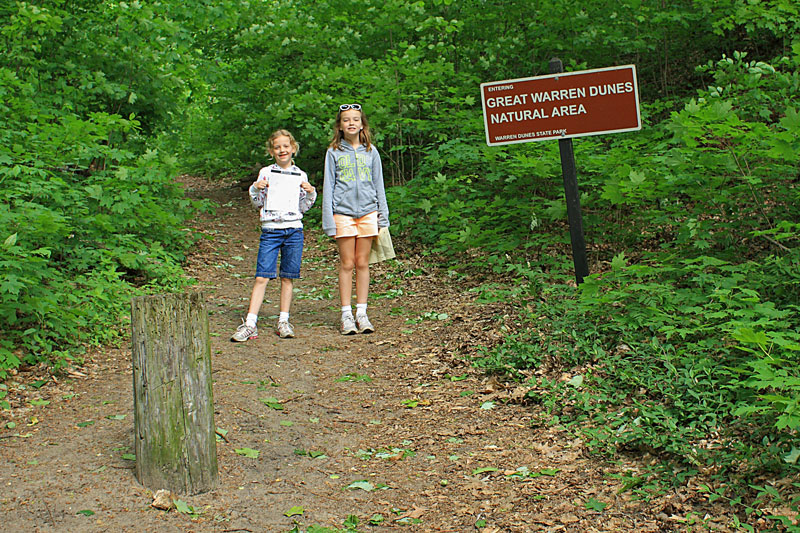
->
[322,140,389,237]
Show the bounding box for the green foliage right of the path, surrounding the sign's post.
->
[428,27,800,514]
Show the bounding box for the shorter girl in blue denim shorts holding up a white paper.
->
[231,130,317,342]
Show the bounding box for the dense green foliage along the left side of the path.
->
[0,2,206,378]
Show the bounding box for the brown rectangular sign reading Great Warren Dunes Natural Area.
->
[481,65,642,146]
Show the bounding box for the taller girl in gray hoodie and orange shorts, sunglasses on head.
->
[322,104,389,335]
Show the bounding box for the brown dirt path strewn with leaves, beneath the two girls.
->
[0,178,684,532]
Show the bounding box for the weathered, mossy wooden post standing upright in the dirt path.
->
[131,293,218,494]
